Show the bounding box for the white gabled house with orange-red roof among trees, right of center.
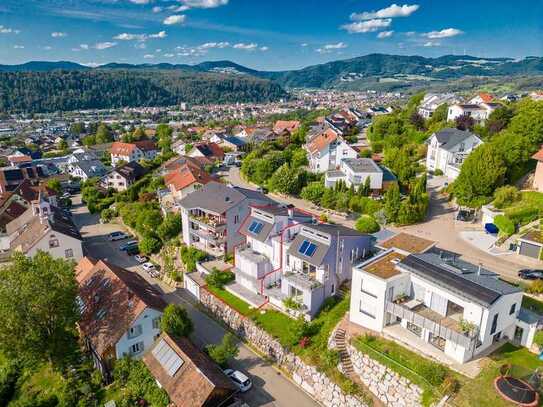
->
[304,128,358,172]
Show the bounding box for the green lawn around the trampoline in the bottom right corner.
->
[453,344,543,407]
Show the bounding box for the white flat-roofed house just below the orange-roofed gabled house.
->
[324,158,383,193]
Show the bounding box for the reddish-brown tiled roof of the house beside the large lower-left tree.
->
[76,257,166,357]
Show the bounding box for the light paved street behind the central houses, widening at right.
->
[226,167,541,280]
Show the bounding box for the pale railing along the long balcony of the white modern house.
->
[386,301,479,349]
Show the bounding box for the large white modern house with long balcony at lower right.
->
[349,248,537,363]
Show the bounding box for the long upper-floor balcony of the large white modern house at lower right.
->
[385,300,479,349]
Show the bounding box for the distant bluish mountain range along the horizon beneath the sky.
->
[0,54,543,88]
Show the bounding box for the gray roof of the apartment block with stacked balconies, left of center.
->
[179,181,247,214]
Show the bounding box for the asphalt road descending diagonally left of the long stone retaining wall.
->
[72,196,319,407]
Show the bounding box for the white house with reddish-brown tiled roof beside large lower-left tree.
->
[76,257,166,381]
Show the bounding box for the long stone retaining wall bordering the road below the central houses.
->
[200,289,367,407]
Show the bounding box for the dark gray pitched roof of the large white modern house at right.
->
[400,253,522,306]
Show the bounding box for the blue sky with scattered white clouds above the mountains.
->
[0,0,543,70]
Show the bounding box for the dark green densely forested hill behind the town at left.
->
[0,69,288,112]
